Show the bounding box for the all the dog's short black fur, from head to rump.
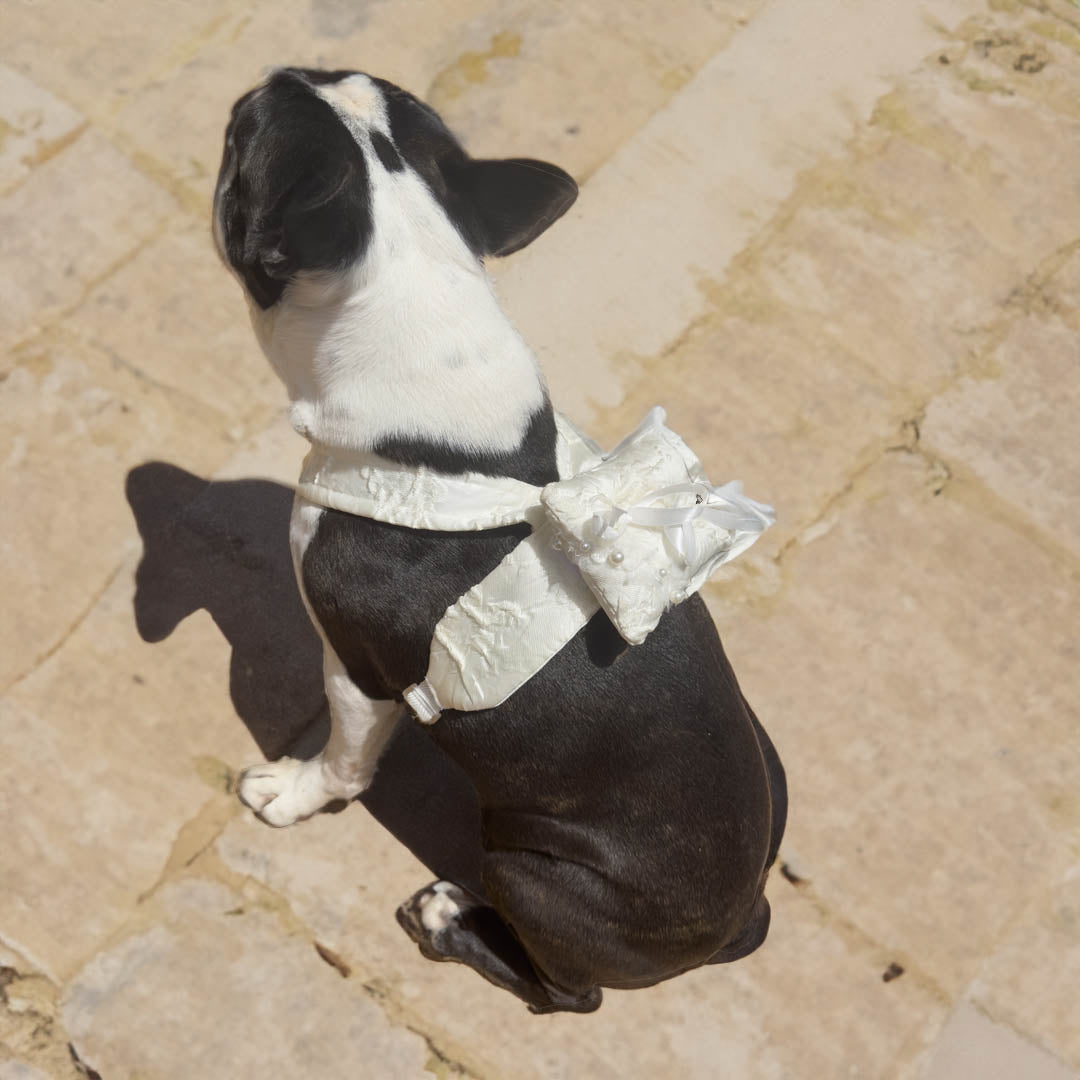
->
[212,69,786,1012]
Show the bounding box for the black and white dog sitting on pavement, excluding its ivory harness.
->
[214,68,786,1012]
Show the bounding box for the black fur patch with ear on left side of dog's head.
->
[216,69,372,308]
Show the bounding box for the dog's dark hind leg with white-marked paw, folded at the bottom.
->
[397,881,603,1013]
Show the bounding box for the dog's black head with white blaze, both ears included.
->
[214,68,578,310]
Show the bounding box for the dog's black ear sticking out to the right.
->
[447,158,578,255]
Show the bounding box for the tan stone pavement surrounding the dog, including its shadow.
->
[0,0,1080,1080]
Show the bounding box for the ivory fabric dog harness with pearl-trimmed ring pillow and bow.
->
[297,407,774,724]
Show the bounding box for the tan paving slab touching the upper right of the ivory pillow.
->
[591,266,912,565]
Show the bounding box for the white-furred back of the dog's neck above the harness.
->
[245,165,554,477]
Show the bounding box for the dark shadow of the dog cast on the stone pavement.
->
[126,461,482,892]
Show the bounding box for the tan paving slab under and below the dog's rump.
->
[217,812,945,1080]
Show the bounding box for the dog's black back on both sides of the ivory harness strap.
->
[303,511,786,987]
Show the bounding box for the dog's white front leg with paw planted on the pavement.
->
[238,643,401,826]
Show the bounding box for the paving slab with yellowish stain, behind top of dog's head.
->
[108,0,743,213]
